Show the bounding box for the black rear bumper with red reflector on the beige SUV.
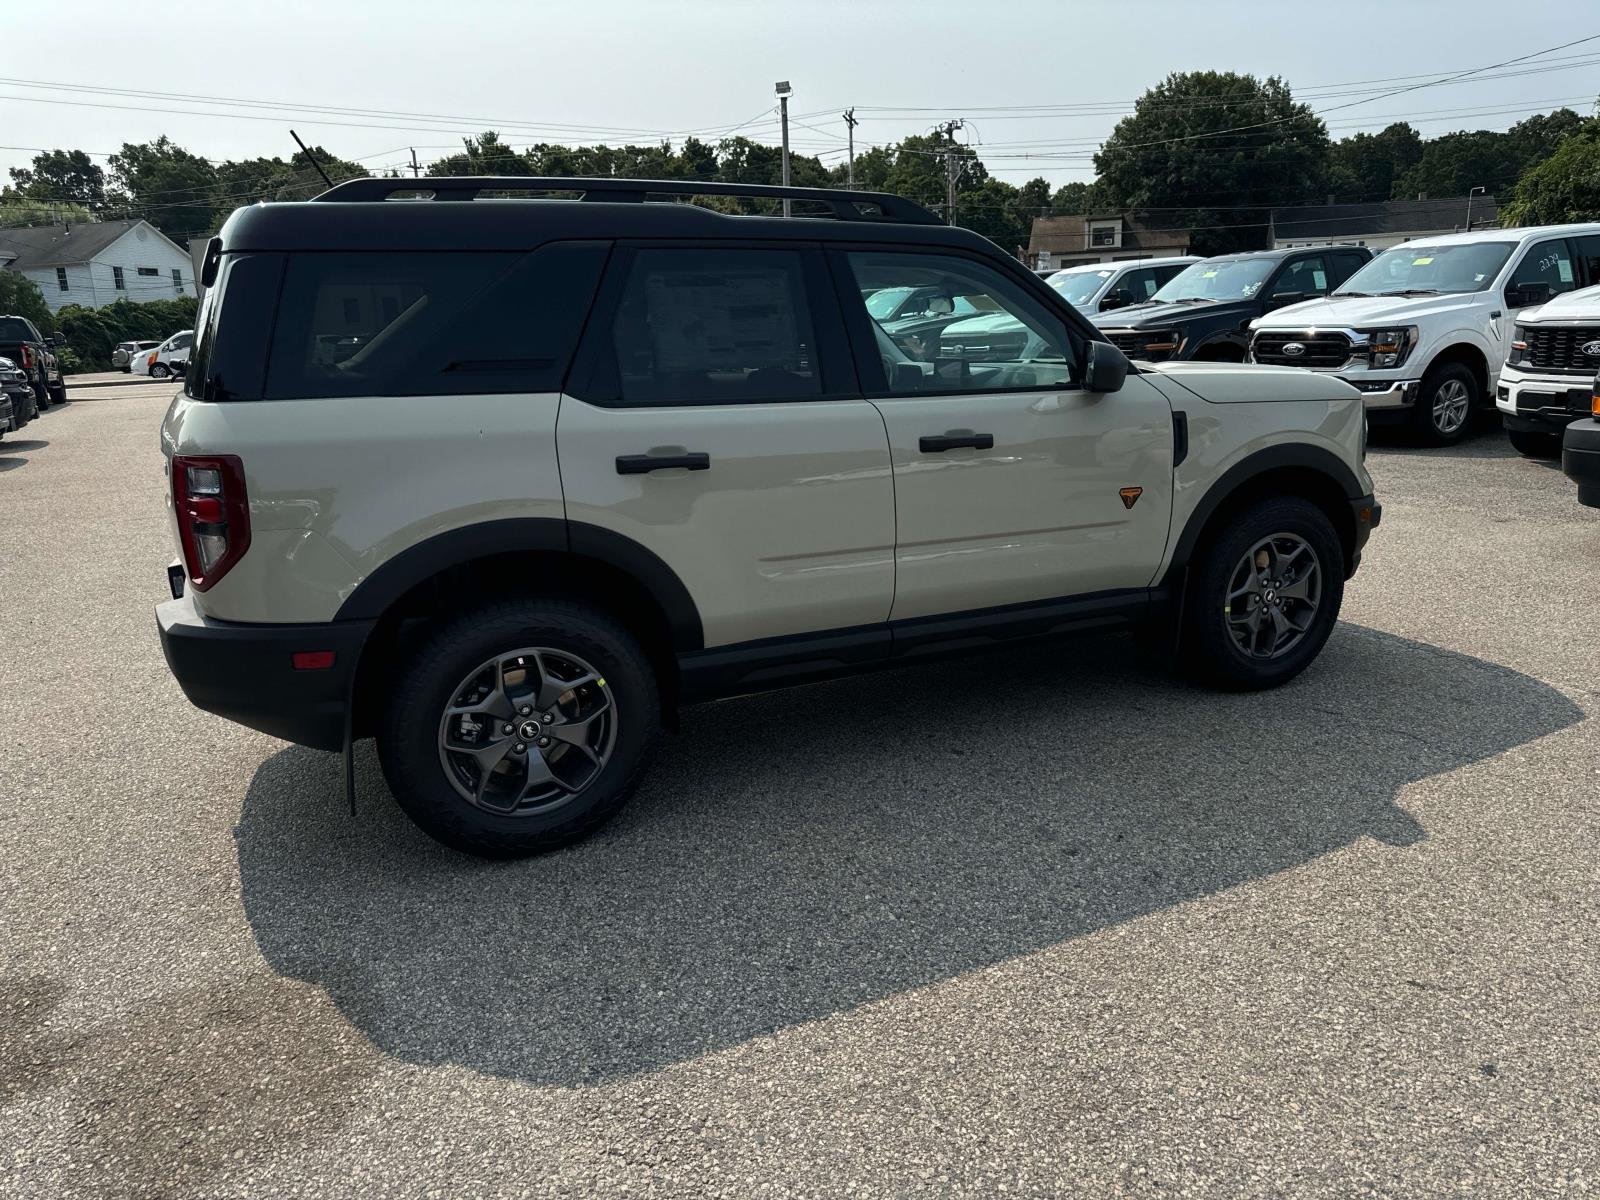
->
[155,595,374,750]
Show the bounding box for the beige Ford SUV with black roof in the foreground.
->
[157,178,1381,856]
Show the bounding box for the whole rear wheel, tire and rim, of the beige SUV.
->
[378,600,661,858]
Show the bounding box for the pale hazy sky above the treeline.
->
[0,0,1600,184]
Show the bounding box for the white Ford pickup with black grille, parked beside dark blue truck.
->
[1250,224,1600,445]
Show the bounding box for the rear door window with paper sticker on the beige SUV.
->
[611,250,822,405]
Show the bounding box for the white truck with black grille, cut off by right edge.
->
[1494,286,1600,458]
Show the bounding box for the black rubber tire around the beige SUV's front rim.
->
[1181,496,1344,691]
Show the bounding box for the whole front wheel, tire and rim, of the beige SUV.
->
[1182,496,1344,691]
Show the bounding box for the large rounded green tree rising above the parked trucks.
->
[1094,70,1330,254]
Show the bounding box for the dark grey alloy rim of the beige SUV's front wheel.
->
[1222,533,1322,659]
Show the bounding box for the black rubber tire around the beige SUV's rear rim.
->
[378,600,661,858]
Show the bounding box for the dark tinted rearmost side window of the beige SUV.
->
[259,242,608,400]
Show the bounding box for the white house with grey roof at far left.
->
[0,221,195,312]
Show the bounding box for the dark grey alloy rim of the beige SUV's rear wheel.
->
[438,646,618,816]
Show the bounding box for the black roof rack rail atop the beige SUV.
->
[312,174,944,226]
